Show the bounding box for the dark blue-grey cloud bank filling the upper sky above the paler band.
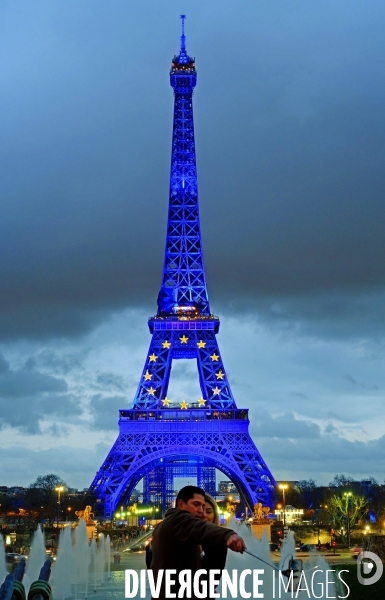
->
[0,0,385,339]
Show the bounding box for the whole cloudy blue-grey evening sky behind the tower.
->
[0,0,385,488]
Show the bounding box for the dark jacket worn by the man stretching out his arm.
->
[151,508,235,600]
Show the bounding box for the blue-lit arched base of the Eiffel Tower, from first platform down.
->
[88,409,274,517]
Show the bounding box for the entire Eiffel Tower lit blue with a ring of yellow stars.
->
[90,15,275,518]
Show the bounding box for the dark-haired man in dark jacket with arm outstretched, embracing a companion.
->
[151,485,246,600]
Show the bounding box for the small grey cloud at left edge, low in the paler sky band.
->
[0,356,82,434]
